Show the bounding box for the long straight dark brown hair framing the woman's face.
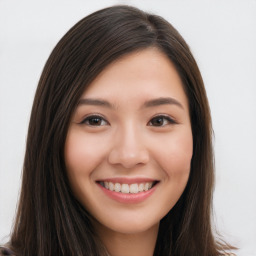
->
[4,6,236,256]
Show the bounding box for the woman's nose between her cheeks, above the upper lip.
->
[108,127,149,169]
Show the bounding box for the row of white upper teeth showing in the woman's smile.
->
[100,181,153,194]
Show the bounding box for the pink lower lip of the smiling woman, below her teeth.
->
[97,183,157,204]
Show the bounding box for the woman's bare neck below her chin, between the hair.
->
[94,224,159,256]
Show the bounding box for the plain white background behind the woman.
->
[0,0,256,256]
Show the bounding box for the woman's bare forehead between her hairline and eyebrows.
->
[82,48,188,110]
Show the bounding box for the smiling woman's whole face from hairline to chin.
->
[65,48,193,233]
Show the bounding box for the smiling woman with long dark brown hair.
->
[0,6,236,256]
